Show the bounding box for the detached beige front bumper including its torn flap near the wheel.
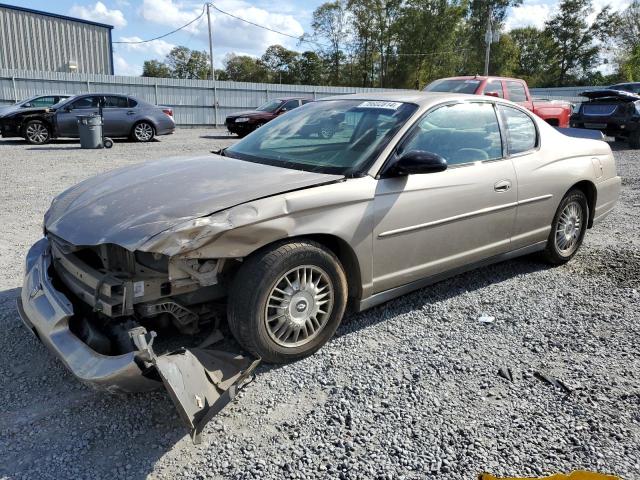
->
[18,238,260,443]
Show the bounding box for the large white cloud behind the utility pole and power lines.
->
[140,0,304,59]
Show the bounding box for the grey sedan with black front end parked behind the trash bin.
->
[0,93,175,145]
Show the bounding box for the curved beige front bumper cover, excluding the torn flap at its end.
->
[18,238,162,392]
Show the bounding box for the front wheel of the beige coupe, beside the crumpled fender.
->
[227,240,347,363]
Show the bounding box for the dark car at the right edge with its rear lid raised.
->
[571,88,640,148]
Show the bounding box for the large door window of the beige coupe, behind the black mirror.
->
[401,102,502,165]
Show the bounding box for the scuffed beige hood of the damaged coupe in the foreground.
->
[45,155,344,250]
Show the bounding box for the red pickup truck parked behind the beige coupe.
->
[424,76,573,128]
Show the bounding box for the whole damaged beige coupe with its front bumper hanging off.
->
[19,92,620,440]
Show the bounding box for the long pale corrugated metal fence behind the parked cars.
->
[0,69,589,126]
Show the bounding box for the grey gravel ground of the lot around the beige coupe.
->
[0,130,640,480]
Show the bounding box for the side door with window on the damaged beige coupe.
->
[373,101,517,293]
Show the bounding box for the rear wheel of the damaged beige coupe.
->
[543,190,589,265]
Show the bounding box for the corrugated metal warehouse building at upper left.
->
[0,3,113,75]
